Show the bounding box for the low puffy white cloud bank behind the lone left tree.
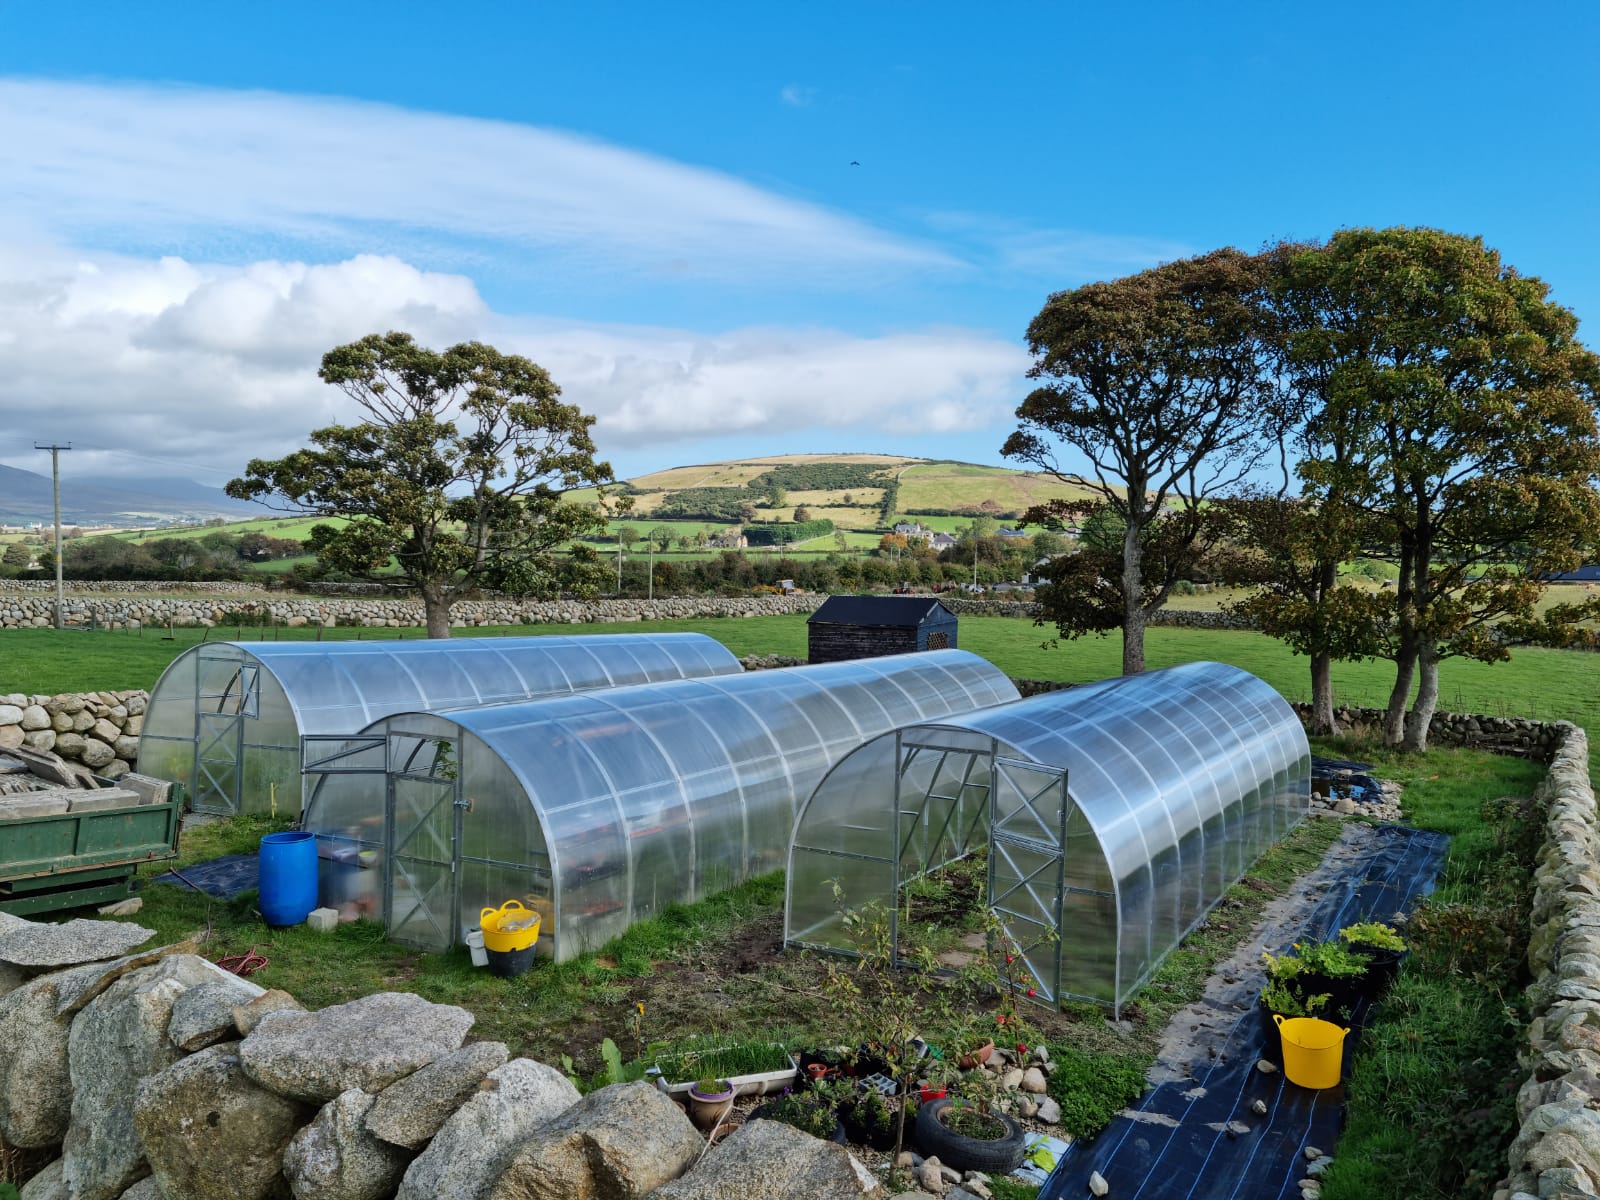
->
[0,246,1029,483]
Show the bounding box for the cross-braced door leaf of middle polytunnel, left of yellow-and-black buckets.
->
[384,734,461,950]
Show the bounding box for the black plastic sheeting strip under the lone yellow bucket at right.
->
[1038,826,1450,1200]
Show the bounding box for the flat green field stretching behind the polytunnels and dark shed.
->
[0,614,1600,746]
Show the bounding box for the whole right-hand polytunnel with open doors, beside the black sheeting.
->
[784,662,1310,1013]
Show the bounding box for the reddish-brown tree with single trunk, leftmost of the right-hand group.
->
[1002,250,1278,675]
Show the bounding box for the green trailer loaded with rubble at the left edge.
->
[0,787,182,917]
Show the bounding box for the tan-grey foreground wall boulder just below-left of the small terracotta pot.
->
[486,1082,704,1200]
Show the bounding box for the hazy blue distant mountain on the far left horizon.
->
[0,462,262,525]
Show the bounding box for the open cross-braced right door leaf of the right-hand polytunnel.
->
[989,757,1070,1003]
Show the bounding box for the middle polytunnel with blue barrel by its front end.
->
[302,650,1018,960]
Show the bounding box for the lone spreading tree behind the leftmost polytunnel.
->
[227,333,613,637]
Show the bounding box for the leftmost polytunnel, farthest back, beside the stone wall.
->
[139,634,742,816]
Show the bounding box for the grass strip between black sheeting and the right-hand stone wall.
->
[1323,741,1544,1200]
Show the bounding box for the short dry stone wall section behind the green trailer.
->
[0,691,150,779]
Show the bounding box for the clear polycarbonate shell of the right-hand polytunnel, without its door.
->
[786,662,1310,1005]
